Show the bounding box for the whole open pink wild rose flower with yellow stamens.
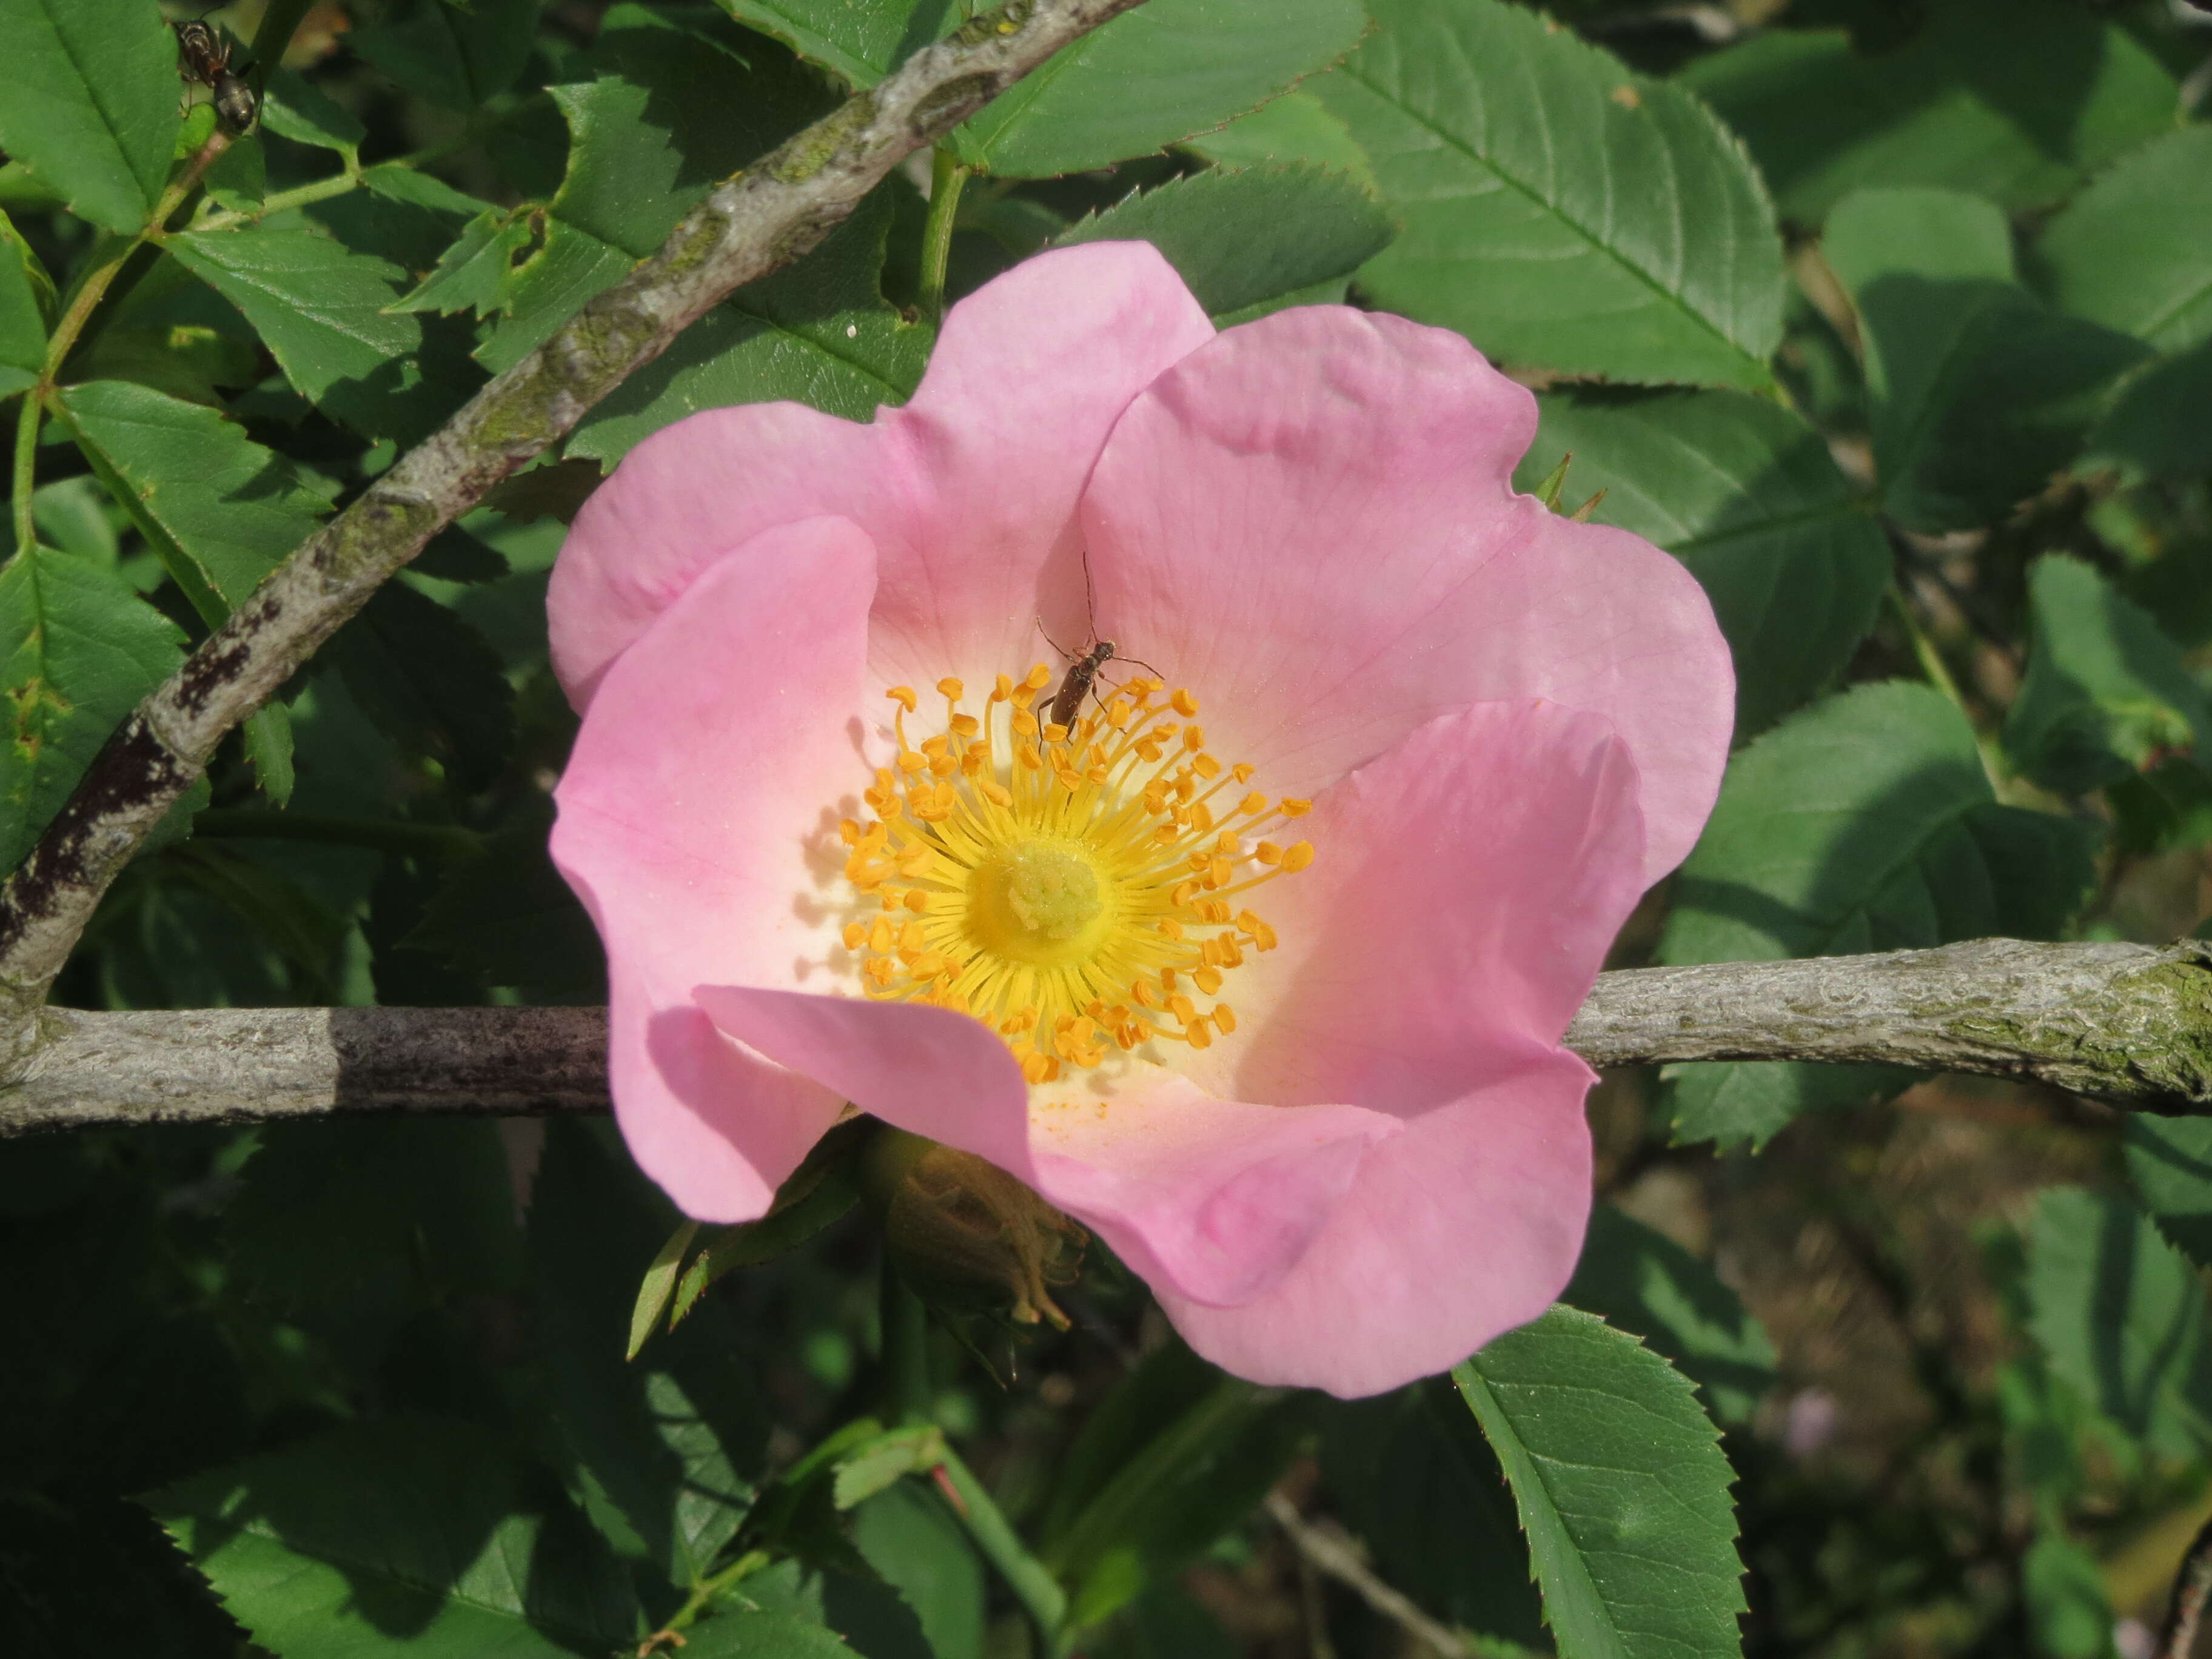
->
[551,243,1732,1396]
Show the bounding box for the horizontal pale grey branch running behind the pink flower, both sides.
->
[0,940,2212,1134]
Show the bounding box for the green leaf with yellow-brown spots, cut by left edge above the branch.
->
[0,546,184,870]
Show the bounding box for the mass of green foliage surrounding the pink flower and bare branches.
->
[0,0,2212,1659]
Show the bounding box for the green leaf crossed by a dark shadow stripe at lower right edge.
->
[2026,1188,2212,1458]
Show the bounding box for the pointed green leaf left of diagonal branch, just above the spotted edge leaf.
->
[62,380,330,626]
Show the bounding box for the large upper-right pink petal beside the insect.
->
[1082,305,1734,883]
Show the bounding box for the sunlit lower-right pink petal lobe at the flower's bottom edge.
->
[1155,1051,1593,1398]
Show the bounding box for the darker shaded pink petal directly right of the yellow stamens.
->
[1205,701,1643,1115]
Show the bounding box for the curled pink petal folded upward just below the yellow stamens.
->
[694,987,1398,1303]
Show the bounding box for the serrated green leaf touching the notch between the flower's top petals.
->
[1053,164,1392,321]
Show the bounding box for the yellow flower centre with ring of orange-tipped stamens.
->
[839,663,1314,1084]
